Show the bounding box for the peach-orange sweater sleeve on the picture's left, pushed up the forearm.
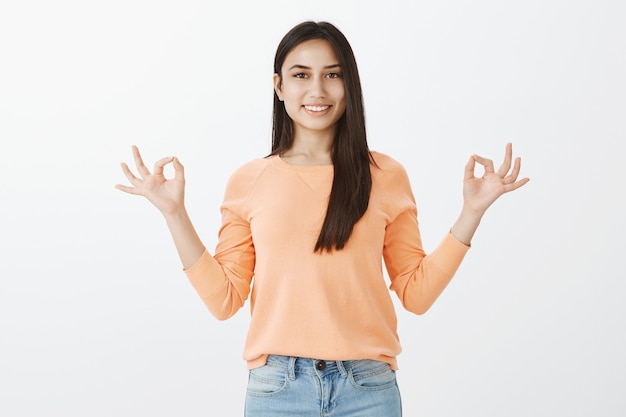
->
[185,165,255,320]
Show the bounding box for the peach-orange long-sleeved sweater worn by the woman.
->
[185,152,468,369]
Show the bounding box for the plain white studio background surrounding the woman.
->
[0,0,626,417]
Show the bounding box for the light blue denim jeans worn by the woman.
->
[245,355,402,417]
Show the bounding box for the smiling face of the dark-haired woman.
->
[274,39,346,140]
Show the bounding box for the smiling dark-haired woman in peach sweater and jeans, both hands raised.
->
[117,22,528,417]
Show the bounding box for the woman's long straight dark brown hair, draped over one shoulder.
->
[270,21,375,252]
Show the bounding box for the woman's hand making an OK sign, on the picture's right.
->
[463,143,529,216]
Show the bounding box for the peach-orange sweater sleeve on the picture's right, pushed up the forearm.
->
[383,161,469,314]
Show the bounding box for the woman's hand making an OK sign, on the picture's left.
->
[115,146,185,216]
